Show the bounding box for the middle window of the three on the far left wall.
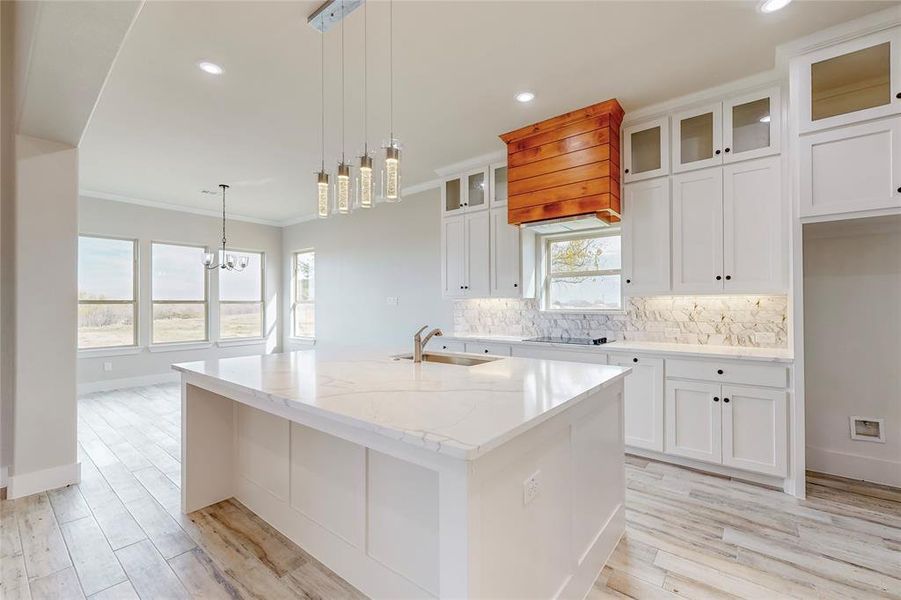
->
[150,242,207,344]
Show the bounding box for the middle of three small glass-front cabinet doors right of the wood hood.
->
[673,102,723,173]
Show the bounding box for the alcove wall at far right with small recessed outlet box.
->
[804,217,901,486]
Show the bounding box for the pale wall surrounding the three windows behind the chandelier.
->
[78,196,282,391]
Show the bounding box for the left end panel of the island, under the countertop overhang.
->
[181,382,235,513]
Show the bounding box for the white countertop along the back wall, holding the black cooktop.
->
[440,333,793,363]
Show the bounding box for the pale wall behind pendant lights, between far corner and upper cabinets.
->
[283,189,453,350]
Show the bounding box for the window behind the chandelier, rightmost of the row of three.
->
[219,250,263,339]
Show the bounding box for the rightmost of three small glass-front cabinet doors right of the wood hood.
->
[723,88,782,163]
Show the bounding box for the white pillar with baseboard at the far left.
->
[9,136,79,498]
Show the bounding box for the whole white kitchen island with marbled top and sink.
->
[174,350,629,598]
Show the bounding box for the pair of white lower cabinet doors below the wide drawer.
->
[664,379,788,477]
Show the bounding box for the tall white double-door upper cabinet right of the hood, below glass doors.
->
[672,156,788,293]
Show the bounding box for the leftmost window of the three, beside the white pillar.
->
[78,235,138,349]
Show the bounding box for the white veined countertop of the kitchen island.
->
[173,349,629,460]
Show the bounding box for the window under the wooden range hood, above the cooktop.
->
[543,229,622,311]
